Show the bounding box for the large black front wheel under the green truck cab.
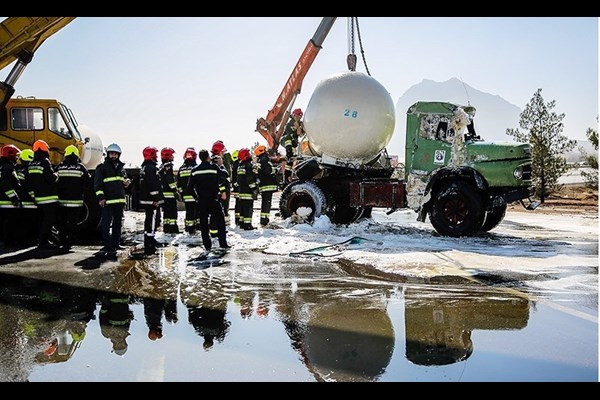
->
[429,182,485,237]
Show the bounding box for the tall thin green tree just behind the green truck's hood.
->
[506,89,577,203]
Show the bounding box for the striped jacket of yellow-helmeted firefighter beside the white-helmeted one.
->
[57,154,92,207]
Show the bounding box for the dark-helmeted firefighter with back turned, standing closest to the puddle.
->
[189,149,230,251]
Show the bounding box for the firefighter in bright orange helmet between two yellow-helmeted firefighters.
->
[26,139,58,249]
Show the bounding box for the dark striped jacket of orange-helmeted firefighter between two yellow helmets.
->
[27,151,58,204]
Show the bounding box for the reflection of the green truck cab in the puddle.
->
[404,289,529,365]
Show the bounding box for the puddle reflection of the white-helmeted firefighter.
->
[98,293,133,356]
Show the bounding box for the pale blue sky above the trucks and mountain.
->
[0,17,598,164]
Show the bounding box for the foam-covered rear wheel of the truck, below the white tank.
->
[279,181,327,223]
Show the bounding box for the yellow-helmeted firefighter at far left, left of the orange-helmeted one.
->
[16,149,40,245]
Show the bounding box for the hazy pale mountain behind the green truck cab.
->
[388,78,521,160]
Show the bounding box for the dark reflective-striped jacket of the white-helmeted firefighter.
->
[94,157,127,204]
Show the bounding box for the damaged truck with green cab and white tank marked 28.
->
[279,71,536,237]
